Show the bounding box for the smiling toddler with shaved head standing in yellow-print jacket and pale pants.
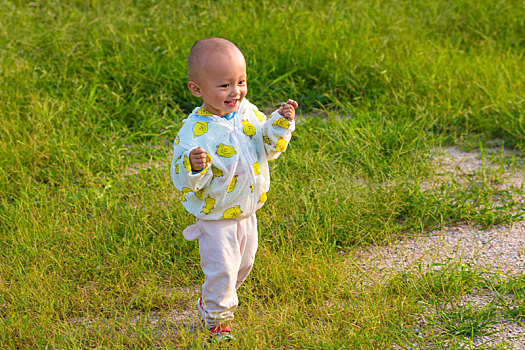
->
[171,38,297,340]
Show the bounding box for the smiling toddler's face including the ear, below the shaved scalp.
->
[188,51,248,116]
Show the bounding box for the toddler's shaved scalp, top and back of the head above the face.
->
[188,38,244,81]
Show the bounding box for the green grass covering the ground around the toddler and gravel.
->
[0,0,525,349]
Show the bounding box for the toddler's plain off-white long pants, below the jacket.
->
[191,214,258,328]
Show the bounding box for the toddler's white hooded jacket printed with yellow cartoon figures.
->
[171,99,295,220]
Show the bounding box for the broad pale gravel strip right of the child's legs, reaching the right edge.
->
[357,222,525,282]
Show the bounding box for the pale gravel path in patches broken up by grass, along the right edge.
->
[355,147,525,349]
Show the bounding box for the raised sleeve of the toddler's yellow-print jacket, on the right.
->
[262,111,295,160]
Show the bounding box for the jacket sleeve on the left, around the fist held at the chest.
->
[171,122,213,192]
